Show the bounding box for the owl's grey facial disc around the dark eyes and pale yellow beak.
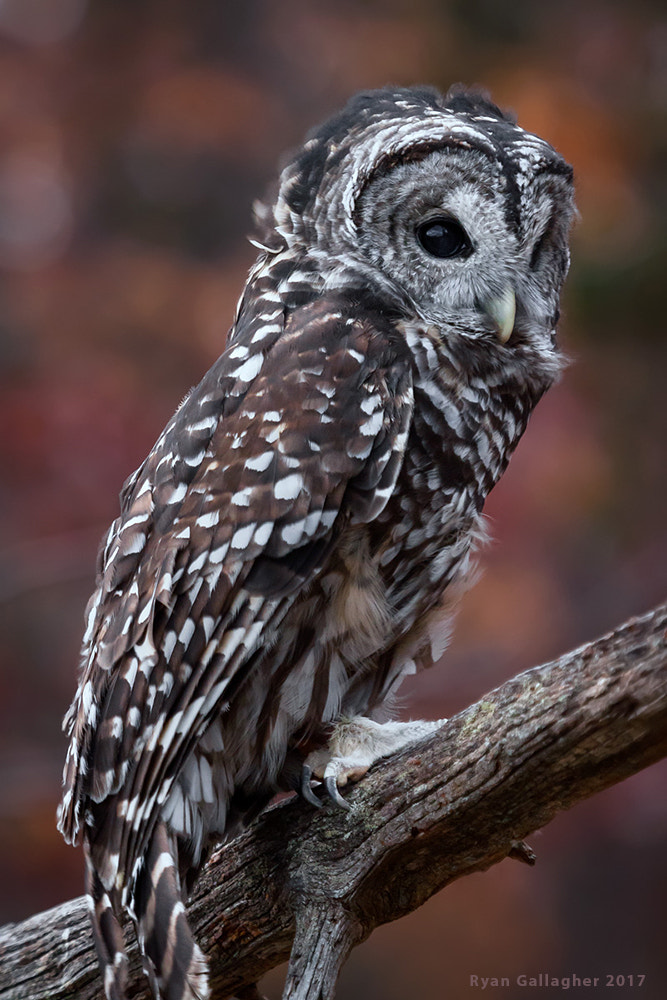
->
[355,137,567,346]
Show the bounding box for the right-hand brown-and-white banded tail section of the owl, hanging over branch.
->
[135,823,210,1000]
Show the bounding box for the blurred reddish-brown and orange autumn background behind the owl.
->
[0,0,667,1000]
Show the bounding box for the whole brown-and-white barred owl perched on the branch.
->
[59,88,573,1000]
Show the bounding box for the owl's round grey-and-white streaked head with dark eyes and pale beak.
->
[259,88,574,360]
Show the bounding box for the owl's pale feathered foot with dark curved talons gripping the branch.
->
[299,715,447,809]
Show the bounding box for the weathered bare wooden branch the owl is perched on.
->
[0,605,667,1000]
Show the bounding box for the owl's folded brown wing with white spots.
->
[60,300,412,884]
